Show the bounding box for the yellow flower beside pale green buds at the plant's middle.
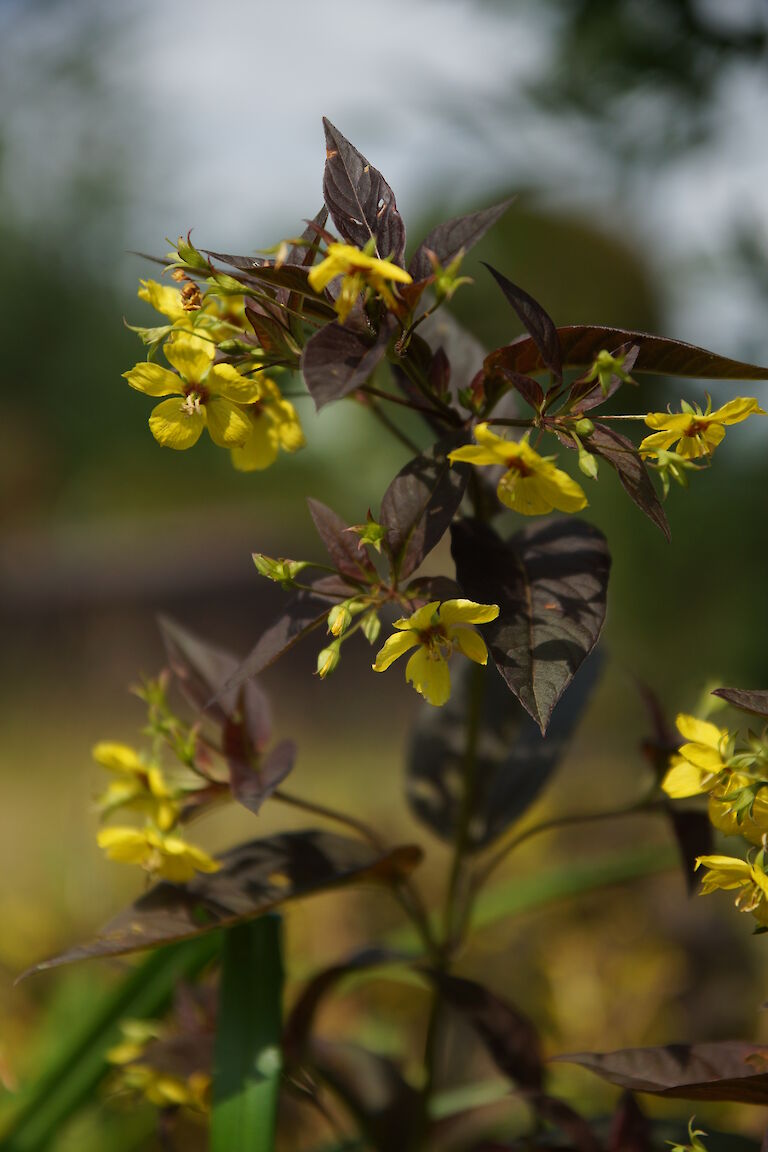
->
[373,600,499,706]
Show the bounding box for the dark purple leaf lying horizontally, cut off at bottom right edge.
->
[556,1040,768,1105]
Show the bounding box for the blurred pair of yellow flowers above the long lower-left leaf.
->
[93,742,220,884]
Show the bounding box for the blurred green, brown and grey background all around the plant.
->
[0,0,768,1150]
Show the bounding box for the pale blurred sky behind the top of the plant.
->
[0,0,768,354]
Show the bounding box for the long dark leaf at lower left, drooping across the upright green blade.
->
[24,829,421,975]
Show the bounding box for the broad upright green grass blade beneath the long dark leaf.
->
[211,915,283,1152]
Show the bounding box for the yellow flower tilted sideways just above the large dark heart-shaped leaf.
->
[448,424,587,516]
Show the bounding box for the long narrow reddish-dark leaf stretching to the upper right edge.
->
[487,324,768,380]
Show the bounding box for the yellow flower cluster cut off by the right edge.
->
[661,714,768,927]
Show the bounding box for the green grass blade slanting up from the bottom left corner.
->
[0,933,221,1152]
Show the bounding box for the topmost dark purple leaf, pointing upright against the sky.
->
[322,116,405,266]
